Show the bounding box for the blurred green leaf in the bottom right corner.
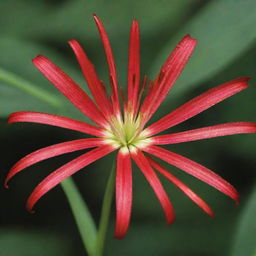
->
[231,186,256,256]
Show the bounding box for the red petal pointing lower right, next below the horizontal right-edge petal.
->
[143,146,239,202]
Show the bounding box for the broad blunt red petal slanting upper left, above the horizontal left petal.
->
[33,55,105,125]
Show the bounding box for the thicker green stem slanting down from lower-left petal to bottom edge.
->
[61,177,97,256]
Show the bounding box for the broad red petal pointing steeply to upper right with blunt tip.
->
[140,35,196,122]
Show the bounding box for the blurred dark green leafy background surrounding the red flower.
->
[0,0,256,256]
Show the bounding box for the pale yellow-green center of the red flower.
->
[105,114,149,148]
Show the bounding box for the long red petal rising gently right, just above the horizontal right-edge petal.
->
[147,77,249,135]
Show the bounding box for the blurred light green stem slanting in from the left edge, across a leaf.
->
[0,68,61,107]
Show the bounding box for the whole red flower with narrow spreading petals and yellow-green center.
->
[5,15,256,238]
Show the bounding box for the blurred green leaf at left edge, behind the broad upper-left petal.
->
[0,37,88,118]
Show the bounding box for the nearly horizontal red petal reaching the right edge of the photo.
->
[151,122,256,145]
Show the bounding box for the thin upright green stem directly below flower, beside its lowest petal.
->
[95,163,115,256]
